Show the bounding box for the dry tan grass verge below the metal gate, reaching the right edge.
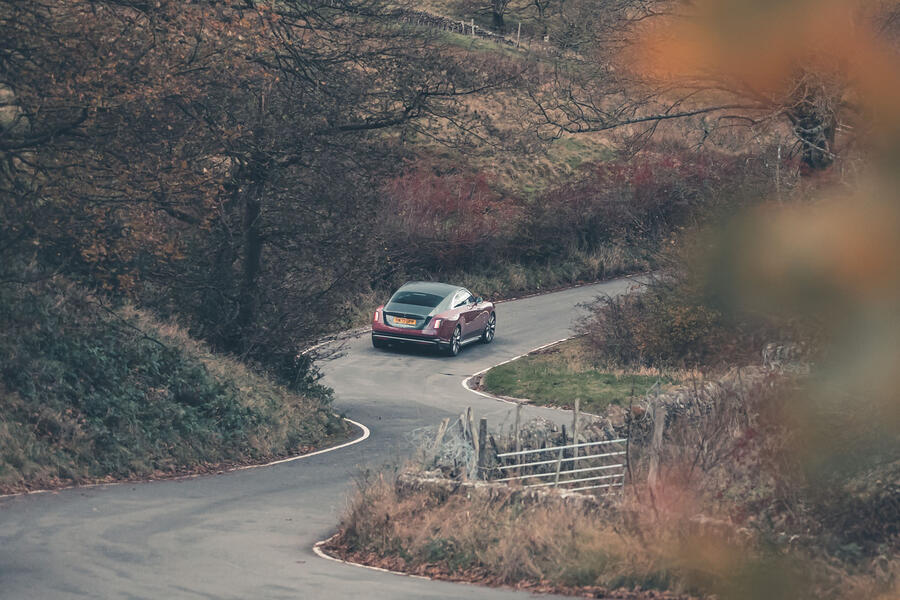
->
[329,468,900,600]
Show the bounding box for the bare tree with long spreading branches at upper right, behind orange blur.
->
[530,0,880,170]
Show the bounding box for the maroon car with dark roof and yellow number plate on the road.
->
[372,281,497,356]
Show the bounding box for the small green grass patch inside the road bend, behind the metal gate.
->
[481,338,678,413]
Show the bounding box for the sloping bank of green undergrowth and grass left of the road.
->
[0,282,351,492]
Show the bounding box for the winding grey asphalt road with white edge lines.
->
[0,280,648,600]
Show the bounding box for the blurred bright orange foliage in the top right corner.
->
[631,0,900,134]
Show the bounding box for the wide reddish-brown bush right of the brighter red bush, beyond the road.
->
[522,150,772,256]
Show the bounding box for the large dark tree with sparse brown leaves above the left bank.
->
[0,0,515,382]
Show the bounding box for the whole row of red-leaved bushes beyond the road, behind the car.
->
[377,147,775,282]
